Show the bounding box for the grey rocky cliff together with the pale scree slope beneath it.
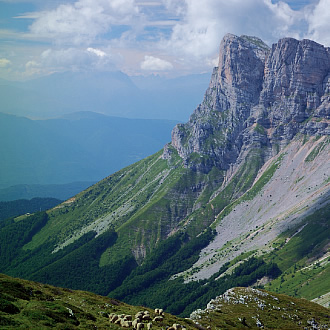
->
[163,34,330,281]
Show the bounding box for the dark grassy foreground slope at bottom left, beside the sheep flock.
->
[0,274,194,329]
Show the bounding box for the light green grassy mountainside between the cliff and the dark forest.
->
[20,151,227,265]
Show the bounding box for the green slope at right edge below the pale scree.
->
[266,205,330,300]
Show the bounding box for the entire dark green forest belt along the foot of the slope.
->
[0,212,280,316]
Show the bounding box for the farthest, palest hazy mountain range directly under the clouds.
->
[0,72,209,121]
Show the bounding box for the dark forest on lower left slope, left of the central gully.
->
[0,212,137,295]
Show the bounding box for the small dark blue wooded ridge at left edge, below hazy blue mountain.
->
[0,197,62,225]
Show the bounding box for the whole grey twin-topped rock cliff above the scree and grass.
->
[163,34,330,173]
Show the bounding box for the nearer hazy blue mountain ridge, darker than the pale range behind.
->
[0,112,176,191]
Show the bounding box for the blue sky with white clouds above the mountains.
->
[0,0,330,80]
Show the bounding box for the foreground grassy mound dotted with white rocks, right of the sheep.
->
[190,288,329,329]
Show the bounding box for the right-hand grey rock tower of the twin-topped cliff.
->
[260,38,330,144]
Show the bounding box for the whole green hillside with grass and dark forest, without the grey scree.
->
[0,138,330,317]
